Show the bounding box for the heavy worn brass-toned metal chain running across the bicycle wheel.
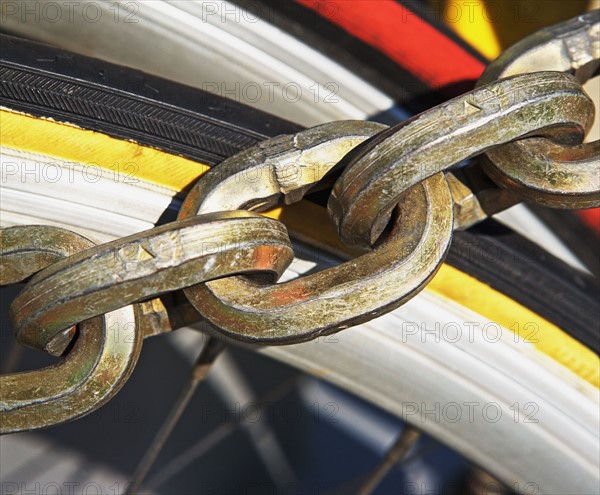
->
[0,11,600,432]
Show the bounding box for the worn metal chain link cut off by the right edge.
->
[478,11,600,208]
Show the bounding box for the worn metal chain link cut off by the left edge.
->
[0,226,142,433]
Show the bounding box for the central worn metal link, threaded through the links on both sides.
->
[180,121,453,344]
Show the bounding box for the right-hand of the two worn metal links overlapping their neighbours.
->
[328,72,594,246]
